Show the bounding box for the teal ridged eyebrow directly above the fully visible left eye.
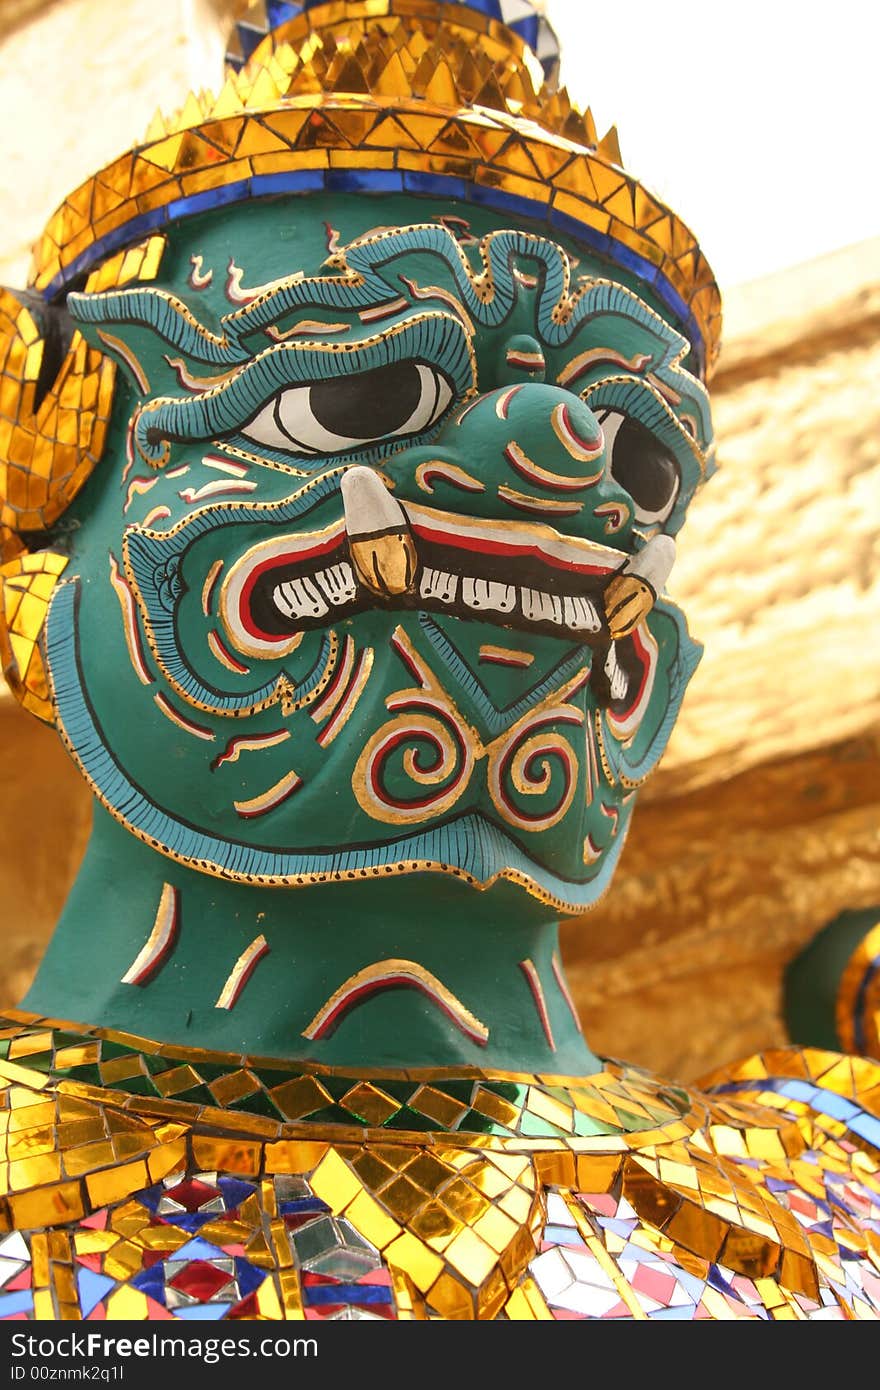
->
[135,310,475,464]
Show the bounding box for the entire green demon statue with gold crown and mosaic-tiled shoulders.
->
[0,0,880,1319]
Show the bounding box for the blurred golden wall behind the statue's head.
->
[0,0,880,1079]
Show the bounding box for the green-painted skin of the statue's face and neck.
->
[25,196,710,1073]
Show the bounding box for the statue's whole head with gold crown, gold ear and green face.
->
[0,0,719,913]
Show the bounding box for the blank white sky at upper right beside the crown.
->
[546,0,880,289]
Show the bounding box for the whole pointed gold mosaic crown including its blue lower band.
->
[32,0,720,375]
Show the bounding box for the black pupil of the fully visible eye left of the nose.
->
[309,361,421,439]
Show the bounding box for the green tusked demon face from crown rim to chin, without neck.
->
[27,197,710,912]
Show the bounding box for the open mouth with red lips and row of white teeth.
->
[221,483,627,656]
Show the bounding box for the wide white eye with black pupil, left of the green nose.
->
[242,361,453,455]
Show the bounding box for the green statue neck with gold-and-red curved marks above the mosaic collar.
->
[22,808,599,1076]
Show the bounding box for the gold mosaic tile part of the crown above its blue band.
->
[23,0,720,375]
